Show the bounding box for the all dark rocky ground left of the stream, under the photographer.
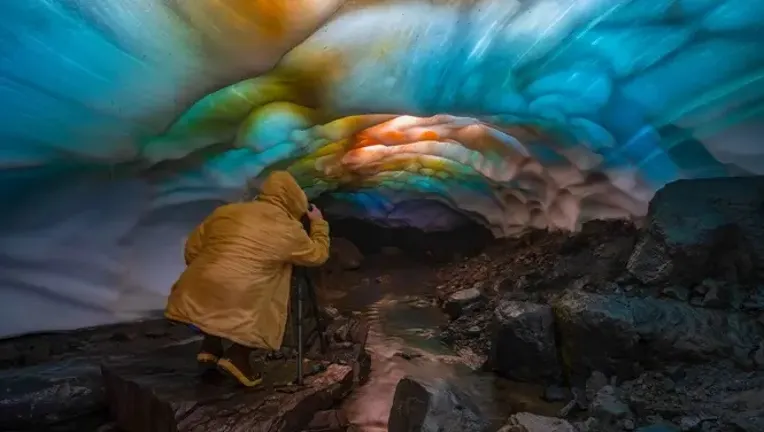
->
[0,309,371,432]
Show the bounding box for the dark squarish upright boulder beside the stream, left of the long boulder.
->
[491,300,561,382]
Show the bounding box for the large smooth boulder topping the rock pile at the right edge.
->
[628,177,764,284]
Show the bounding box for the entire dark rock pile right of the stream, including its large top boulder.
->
[438,178,764,432]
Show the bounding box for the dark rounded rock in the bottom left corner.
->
[0,358,106,430]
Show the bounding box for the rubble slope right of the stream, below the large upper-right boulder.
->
[432,221,764,432]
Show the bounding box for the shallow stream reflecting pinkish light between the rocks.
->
[329,257,561,431]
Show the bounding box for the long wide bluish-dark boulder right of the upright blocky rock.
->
[554,292,759,379]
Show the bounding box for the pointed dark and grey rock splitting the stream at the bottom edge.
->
[388,377,489,432]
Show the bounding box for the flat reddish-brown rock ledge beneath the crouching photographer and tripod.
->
[102,316,371,432]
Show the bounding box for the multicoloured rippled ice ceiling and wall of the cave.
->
[0,0,764,336]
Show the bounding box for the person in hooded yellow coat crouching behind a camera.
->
[165,171,329,387]
